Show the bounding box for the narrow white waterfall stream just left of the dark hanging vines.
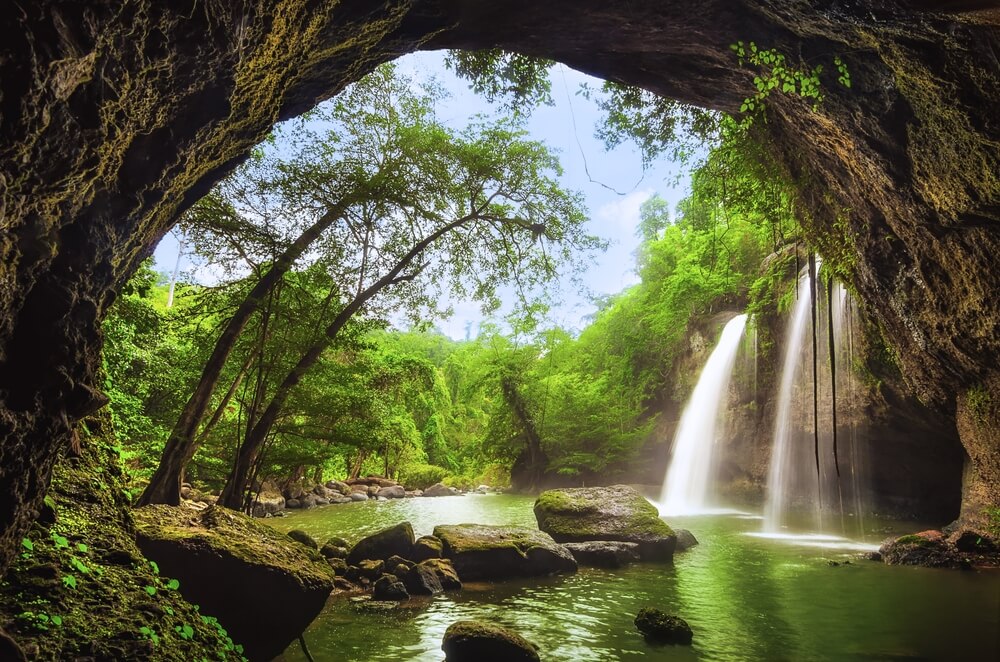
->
[764,257,821,531]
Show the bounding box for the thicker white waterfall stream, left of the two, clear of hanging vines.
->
[660,315,747,515]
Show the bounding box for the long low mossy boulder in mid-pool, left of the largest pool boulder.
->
[425,524,577,581]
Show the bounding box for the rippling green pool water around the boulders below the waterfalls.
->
[263,495,1000,662]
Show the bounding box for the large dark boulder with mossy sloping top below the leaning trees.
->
[135,506,334,660]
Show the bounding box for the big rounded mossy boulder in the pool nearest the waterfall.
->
[535,485,677,561]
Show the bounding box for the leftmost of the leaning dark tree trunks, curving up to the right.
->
[138,201,348,506]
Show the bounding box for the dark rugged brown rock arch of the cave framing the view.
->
[0,0,1000,570]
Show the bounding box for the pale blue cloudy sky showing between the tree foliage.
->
[154,52,688,339]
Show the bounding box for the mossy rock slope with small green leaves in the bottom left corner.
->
[0,417,242,662]
